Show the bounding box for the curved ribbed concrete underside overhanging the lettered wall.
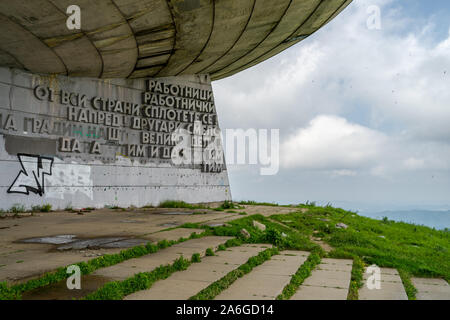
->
[0,0,352,80]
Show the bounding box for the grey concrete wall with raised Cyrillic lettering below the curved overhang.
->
[0,68,231,210]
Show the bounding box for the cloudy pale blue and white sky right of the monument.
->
[213,0,450,210]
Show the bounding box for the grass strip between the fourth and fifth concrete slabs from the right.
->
[189,248,278,300]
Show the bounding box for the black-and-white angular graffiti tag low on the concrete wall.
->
[7,153,53,197]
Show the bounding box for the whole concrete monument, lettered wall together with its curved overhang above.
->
[0,0,351,209]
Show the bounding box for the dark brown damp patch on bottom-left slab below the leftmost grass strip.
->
[22,275,111,300]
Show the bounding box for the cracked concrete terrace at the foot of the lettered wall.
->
[0,206,295,283]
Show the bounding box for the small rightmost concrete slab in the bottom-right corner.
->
[411,278,450,300]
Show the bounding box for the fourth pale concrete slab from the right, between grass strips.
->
[216,250,309,300]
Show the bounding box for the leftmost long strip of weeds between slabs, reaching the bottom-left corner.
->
[0,230,210,300]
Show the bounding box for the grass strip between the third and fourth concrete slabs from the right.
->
[277,249,324,300]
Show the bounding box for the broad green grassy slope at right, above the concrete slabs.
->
[271,204,450,281]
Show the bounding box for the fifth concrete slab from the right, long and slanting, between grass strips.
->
[125,244,270,300]
